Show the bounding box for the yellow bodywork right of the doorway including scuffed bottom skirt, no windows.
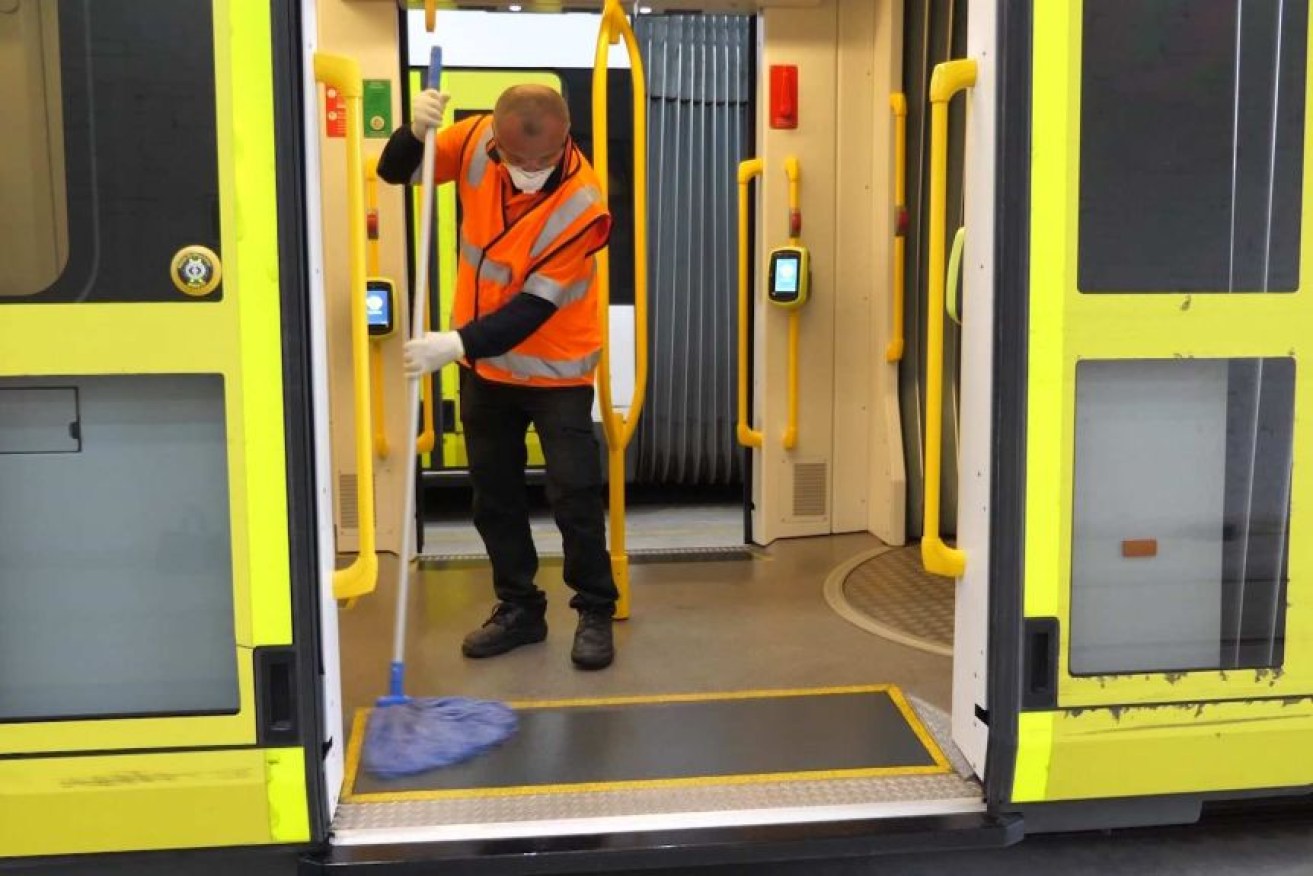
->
[1012,3,1313,802]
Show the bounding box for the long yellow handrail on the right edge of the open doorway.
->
[920,59,976,578]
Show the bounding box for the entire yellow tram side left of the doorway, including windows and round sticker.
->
[0,0,312,856]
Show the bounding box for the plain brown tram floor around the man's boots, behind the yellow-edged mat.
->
[340,535,952,726]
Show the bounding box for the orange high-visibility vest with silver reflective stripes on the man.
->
[452,117,611,386]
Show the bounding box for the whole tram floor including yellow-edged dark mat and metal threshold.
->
[335,535,978,842]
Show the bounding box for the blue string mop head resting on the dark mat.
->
[362,696,517,779]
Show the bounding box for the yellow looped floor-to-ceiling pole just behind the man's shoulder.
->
[592,0,647,620]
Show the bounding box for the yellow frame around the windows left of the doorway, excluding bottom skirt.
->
[0,0,291,754]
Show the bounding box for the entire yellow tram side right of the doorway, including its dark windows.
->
[1014,3,1313,801]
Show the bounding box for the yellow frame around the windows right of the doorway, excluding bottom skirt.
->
[1024,3,1313,708]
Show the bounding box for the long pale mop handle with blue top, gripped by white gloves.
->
[390,46,442,696]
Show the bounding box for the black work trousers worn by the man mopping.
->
[461,366,618,615]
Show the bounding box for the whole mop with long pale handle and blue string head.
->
[361,46,517,779]
